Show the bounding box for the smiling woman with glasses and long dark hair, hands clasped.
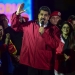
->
[55,21,75,75]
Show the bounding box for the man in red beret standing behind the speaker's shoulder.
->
[50,11,61,38]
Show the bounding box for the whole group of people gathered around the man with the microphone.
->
[0,3,75,75]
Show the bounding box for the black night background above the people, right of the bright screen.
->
[33,0,75,20]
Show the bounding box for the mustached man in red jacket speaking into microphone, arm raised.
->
[11,3,58,75]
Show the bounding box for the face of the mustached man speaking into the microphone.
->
[38,10,50,24]
